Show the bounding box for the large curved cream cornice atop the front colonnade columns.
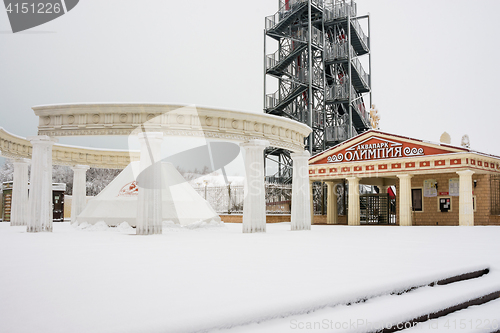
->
[33,104,311,152]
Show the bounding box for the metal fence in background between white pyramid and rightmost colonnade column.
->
[193,183,292,214]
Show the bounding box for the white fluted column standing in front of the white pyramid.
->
[136,132,163,235]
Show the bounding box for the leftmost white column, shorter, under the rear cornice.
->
[10,158,30,226]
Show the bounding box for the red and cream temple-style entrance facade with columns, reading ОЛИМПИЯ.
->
[309,130,500,225]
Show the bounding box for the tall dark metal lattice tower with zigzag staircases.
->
[264,0,371,183]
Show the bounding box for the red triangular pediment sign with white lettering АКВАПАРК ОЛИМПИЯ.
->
[323,136,449,163]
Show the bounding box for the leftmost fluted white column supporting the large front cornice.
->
[28,135,56,232]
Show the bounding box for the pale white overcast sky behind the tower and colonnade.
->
[0,0,500,166]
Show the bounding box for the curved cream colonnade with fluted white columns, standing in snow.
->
[0,104,311,232]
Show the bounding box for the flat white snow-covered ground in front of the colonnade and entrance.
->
[0,222,500,333]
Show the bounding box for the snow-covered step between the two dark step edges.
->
[223,272,500,333]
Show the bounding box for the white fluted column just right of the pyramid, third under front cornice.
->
[240,140,270,232]
